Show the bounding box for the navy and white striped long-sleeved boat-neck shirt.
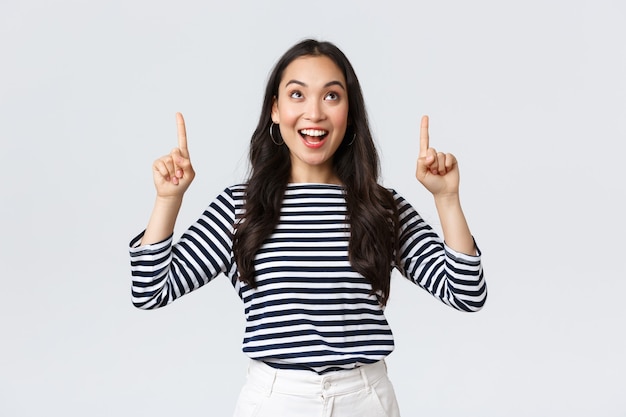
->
[130,184,487,374]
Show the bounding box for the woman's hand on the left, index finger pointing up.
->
[152,113,196,199]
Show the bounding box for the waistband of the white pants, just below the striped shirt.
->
[248,359,387,396]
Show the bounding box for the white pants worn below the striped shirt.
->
[234,360,400,417]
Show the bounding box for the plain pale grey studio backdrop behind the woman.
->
[0,0,626,417]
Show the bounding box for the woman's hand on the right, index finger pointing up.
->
[415,116,459,197]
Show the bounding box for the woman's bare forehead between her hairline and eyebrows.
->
[280,55,346,86]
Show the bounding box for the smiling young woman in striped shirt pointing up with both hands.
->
[130,40,486,417]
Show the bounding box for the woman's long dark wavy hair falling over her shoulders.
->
[233,39,399,305]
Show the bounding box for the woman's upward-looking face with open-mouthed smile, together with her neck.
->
[272,56,348,183]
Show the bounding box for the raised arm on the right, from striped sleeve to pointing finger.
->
[399,116,487,311]
